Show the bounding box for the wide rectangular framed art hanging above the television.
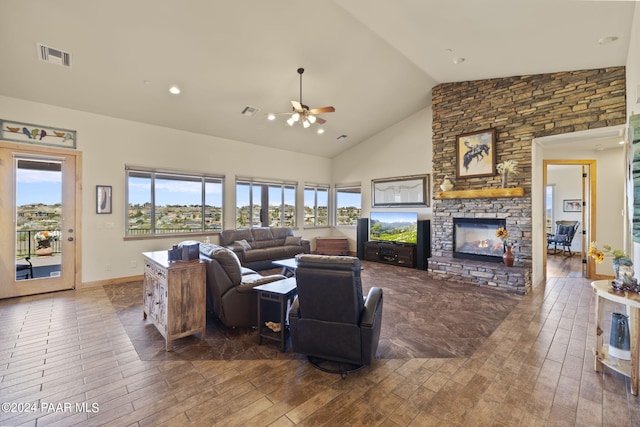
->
[371,174,429,208]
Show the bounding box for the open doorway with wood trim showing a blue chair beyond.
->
[544,160,596,278]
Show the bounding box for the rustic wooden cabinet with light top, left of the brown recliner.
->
[142,251,207,351]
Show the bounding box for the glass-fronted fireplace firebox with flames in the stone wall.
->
[453,218,506,262]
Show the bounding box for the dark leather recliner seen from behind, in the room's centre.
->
[289,255,382,378]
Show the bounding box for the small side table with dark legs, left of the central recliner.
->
[253,277,298,352]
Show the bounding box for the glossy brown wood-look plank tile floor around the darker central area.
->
[0,266,640,426]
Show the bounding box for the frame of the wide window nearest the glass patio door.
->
[124,165,225,239]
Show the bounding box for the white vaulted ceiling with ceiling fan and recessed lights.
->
[0,0,635,158]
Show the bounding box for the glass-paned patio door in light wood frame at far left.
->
[0,142,81,298]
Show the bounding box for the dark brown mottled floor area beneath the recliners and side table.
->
[104,261,522,360]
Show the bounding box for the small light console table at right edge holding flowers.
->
[591,280,640,396]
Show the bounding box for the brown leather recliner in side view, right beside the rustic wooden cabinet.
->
[200,243,285,327]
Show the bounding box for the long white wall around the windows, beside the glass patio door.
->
[0,96,331,283]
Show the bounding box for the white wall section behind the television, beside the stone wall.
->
[332,107,441,251]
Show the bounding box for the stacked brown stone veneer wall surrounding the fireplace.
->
[429,67,626,294]
